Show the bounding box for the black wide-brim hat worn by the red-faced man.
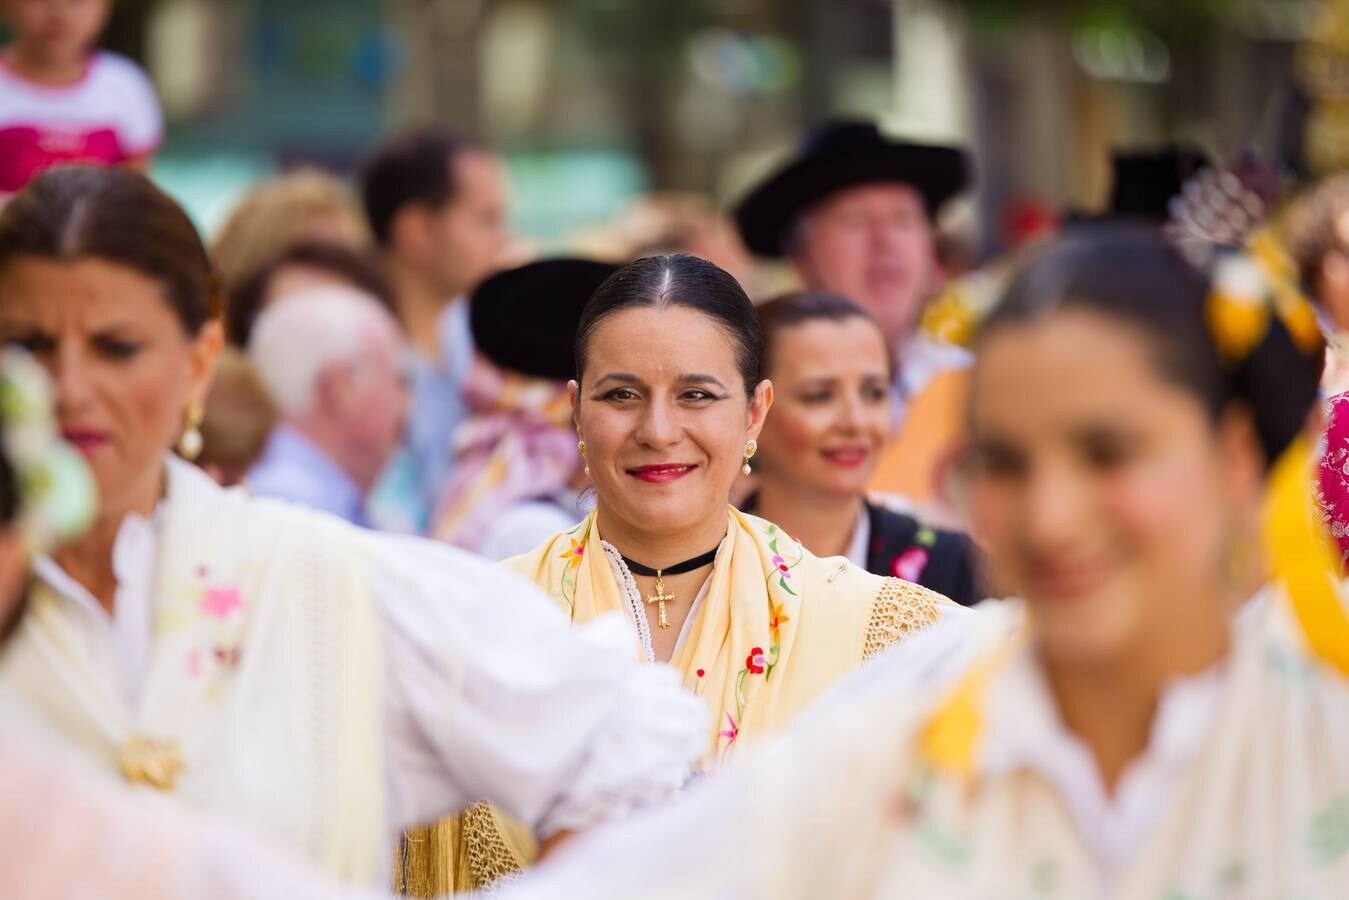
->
[734,121,970,256]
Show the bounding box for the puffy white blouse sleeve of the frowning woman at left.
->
[371,536,707,837]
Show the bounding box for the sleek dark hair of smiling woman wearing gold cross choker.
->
[576,254,764,397]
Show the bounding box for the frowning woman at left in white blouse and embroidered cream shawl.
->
[0,167,703,884]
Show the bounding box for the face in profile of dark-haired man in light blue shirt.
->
[426,151,506,297]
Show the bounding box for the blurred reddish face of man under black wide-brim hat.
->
[792,184,936,347]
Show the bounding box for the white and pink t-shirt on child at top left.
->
[0,51,163,193]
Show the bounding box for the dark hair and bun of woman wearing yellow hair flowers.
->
[978,223,1322,464]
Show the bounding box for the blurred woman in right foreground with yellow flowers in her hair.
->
[506,227,1349,899]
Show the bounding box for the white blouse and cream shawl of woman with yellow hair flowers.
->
[500,602,1349,900]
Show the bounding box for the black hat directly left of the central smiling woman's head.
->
[468,259,622,382]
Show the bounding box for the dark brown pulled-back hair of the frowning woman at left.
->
[0,166,221,336]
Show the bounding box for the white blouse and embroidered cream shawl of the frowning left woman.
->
[0,460,707,882]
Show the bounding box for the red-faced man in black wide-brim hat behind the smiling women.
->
[735,121,969,416]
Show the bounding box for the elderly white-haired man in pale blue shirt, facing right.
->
[247,286,407,525]
